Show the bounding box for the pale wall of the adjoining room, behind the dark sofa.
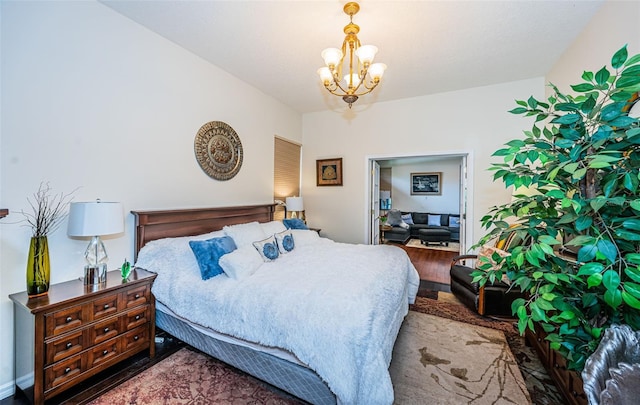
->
[384,158,461,214]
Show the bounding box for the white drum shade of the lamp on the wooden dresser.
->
[67,202,124,236]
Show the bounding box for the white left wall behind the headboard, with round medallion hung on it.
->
[0,1,302,392]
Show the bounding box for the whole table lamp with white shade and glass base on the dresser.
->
[67,200,124,285]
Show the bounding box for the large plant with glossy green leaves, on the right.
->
[474,46,640,371]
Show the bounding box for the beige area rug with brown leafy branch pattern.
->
[389,311,531,405]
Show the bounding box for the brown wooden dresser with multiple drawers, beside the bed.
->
[9,269,156,404]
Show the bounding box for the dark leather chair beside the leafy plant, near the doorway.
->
[449,255,524,317]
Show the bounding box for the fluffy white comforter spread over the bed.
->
[136,232,419,404]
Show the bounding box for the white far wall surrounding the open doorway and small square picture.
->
[302,78,544,246]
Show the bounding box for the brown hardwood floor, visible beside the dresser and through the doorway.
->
[0,240,458,405]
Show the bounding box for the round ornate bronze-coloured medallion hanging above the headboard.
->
[194,121,242,180]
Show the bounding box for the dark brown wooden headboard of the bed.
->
[131,204,275,260]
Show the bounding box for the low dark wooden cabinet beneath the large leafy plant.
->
[525,324,589,405]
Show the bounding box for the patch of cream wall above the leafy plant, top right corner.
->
[546,0,640,94]
